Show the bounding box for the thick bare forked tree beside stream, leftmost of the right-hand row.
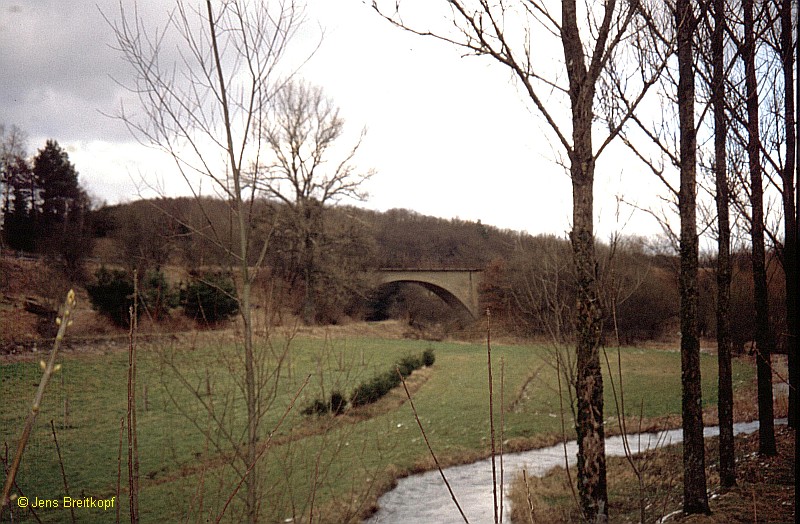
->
[372,0,658,521]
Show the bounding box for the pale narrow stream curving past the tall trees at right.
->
[364,419,786,524]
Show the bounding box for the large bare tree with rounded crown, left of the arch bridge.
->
[256,80,374,323]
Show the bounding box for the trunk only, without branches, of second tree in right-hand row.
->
[675,0,709,513]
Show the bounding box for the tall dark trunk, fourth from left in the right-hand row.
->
[742,0,776,455]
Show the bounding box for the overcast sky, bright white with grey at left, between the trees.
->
[0,0,660,237]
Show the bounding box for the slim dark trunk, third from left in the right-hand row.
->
[711,0,736,488]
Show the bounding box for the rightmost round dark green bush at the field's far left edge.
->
[182,273,239,324]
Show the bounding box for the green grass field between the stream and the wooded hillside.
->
[0,336,753,522]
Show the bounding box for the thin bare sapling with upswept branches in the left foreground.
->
[107,0,310,522]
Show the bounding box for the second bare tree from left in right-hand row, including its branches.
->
[624,0,709,513]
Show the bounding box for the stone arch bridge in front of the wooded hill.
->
[371,268,483,318]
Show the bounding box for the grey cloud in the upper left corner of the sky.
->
[0,0,166,141]
